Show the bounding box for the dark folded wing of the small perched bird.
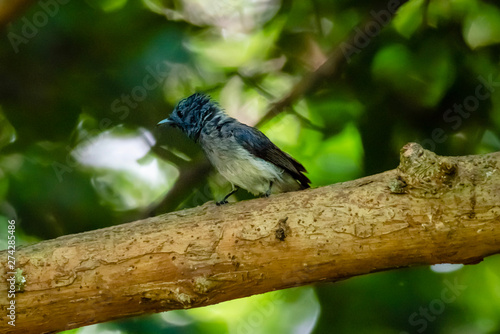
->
[231,124,311,188]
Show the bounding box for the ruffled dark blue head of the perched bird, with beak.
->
[158,93,221,141]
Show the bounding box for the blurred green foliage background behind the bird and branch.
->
[0,0,500,333]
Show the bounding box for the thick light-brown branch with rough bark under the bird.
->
[0,144,500,333]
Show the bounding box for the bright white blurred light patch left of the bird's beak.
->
[72,129,179,210]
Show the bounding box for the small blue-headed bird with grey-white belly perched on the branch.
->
[158,93,311,205]
